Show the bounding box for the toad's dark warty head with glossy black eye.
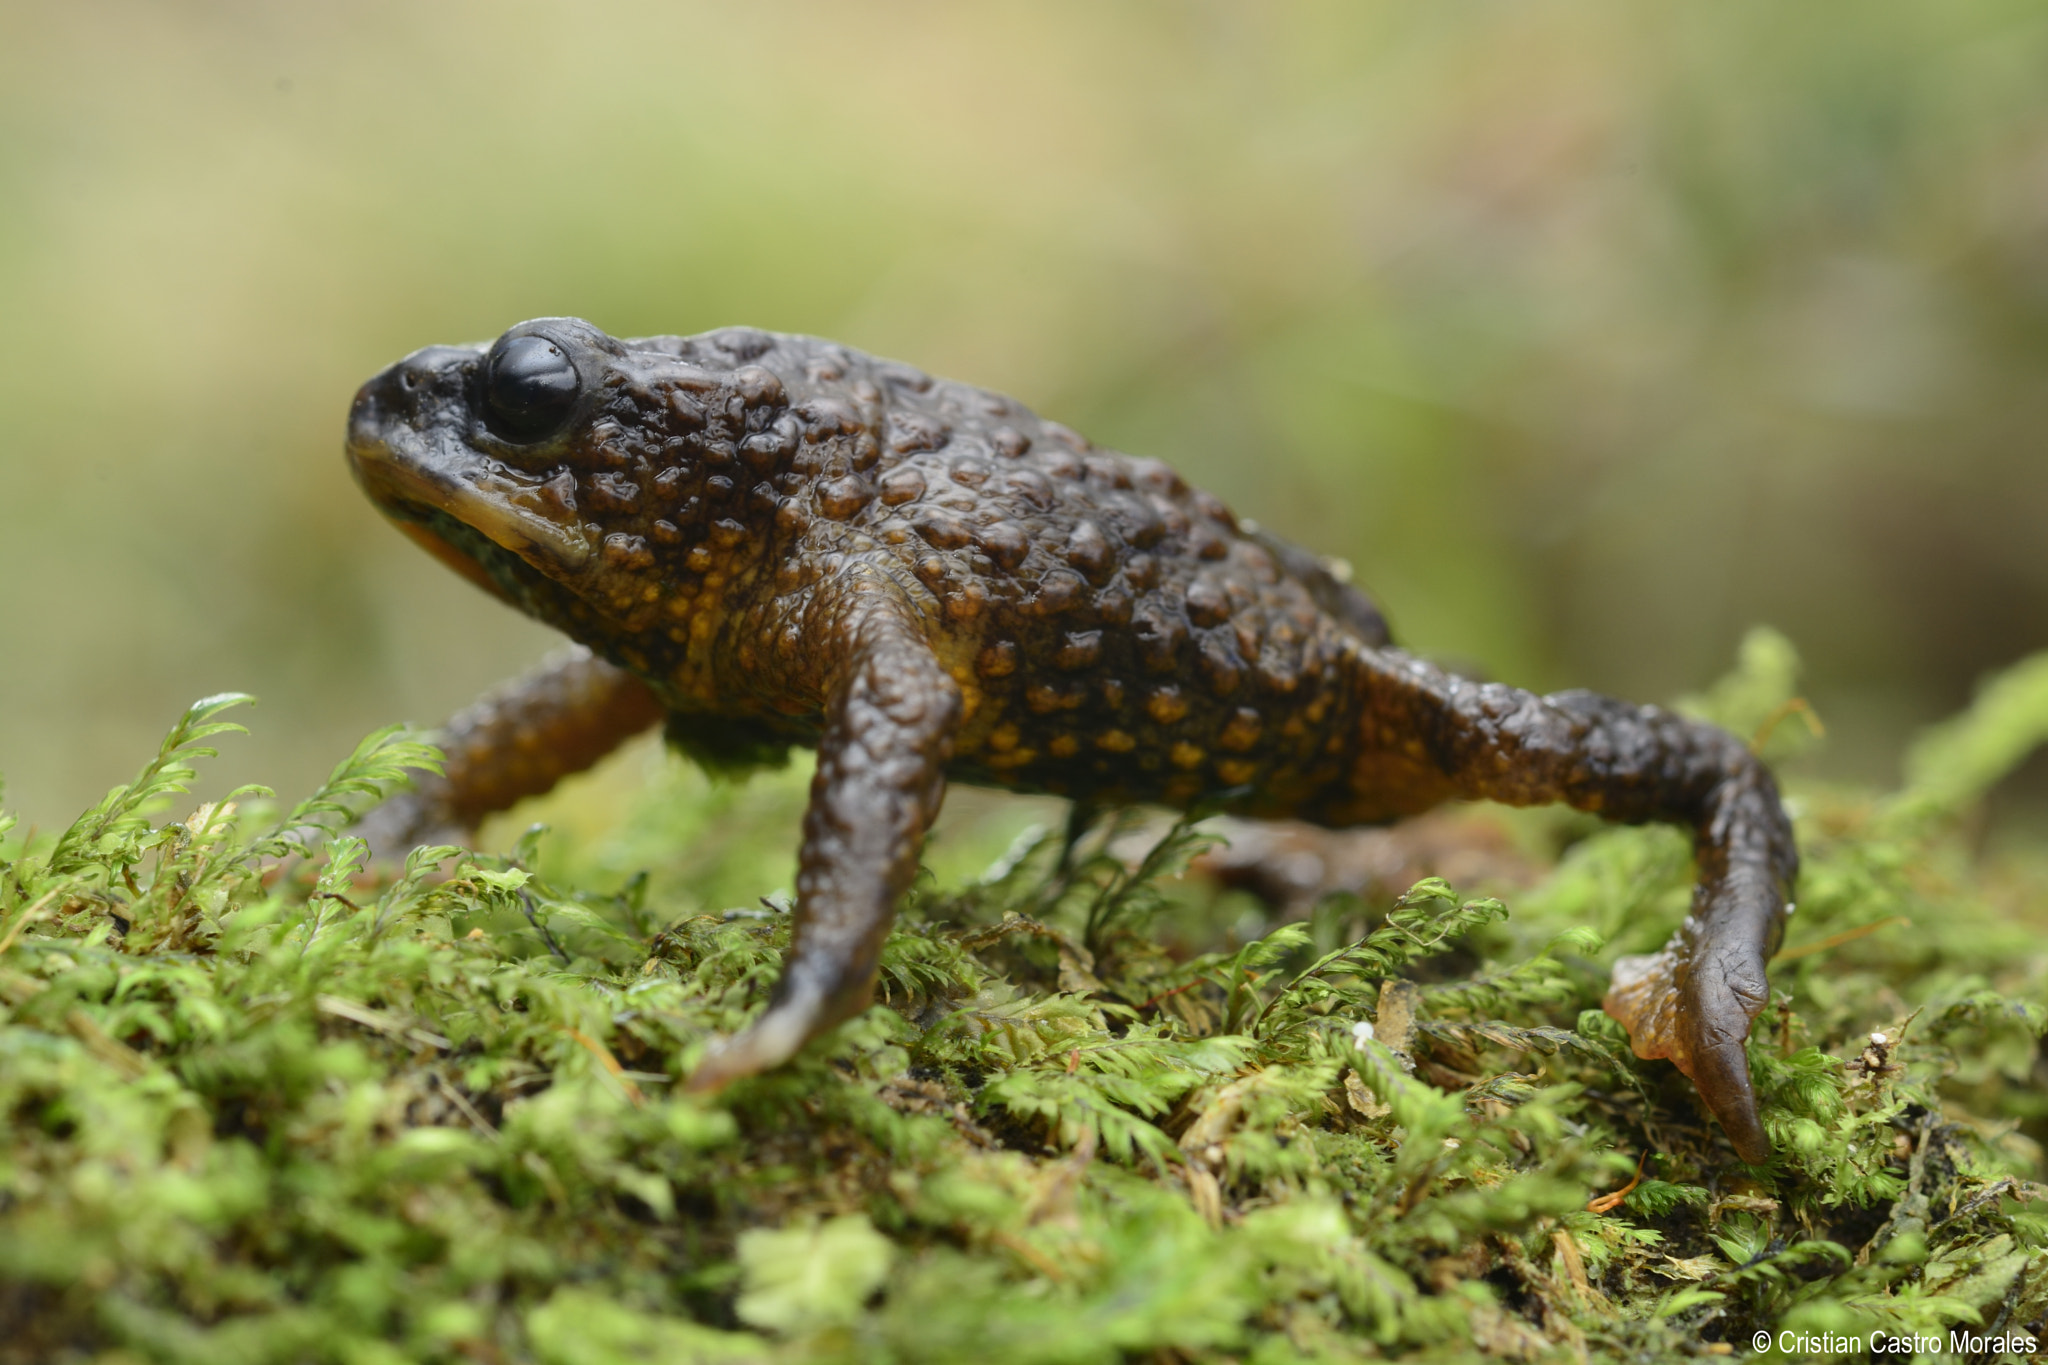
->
[348,317,797,636]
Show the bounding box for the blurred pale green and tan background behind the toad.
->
[0,0,2048,827]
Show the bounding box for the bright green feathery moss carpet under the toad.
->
[0,636,2048,1365]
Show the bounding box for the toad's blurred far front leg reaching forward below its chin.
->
[358,645,662,857]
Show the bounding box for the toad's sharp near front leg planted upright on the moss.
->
[688,602,961,1091]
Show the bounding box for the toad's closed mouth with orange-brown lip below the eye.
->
[348,434,592,579]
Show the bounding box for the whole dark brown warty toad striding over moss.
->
[348,319,1798,1162]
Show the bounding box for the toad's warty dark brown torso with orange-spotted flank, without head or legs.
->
[489,329,1386,823]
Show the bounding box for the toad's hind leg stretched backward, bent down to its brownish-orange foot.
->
[1352,651,1798,1162]
